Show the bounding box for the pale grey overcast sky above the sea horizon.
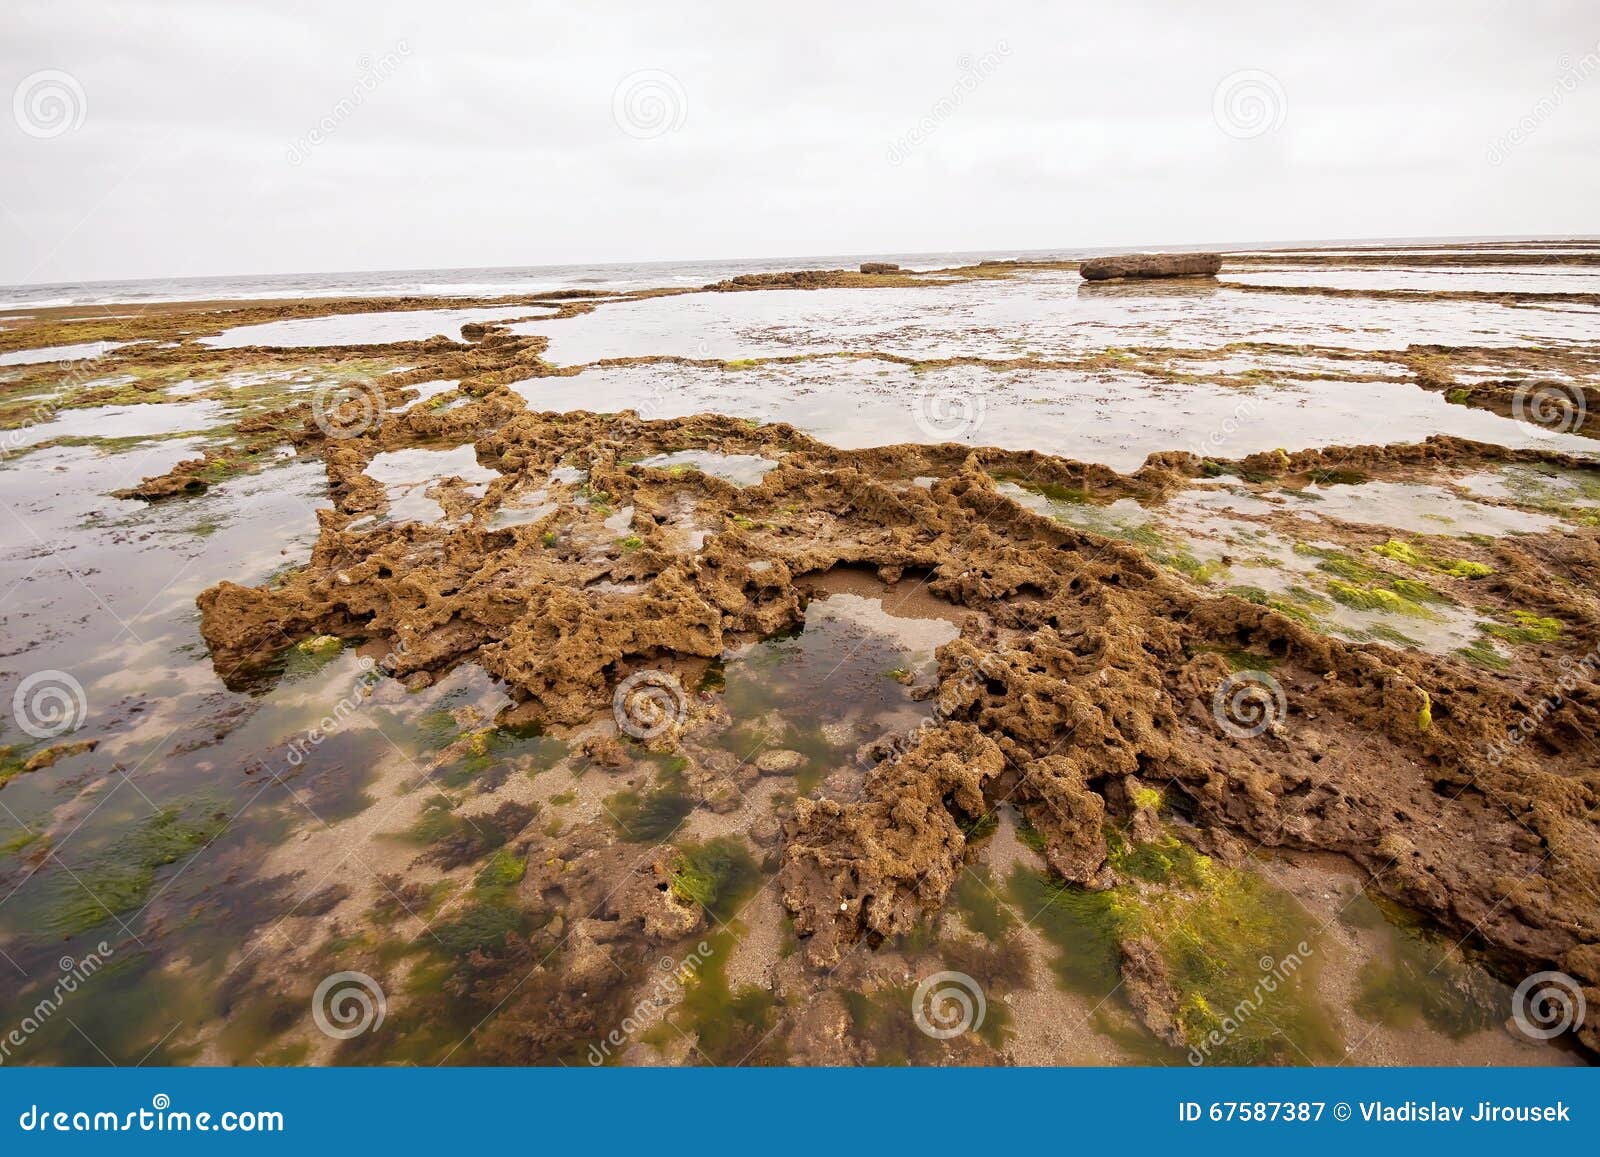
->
[0,0,1600,283]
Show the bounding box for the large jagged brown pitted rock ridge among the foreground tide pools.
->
[190,389,1600,1049]
